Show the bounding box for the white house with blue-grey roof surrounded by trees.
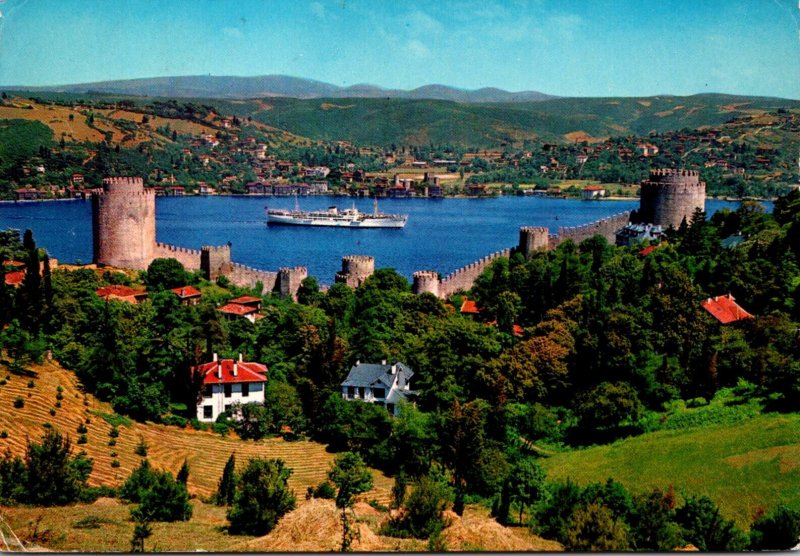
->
[342,360,415,415]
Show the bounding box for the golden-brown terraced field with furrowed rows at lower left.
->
[0,362,392,504]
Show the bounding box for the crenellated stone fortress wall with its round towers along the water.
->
[92,169,692,299]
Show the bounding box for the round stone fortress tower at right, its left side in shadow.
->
[636,168,706,228]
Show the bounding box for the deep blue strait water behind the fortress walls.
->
[0,197,752,284]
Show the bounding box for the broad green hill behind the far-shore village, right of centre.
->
[222,94,800,147]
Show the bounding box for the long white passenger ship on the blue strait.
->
[266,199,408,228]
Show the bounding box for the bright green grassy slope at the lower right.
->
[541,414,800,528]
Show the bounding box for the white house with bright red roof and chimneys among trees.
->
[192,353,267,423]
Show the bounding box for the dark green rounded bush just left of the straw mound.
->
[227,458,295,535]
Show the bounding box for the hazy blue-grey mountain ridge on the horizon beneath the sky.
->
[3,75,558,103]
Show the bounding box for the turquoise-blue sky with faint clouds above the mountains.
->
[0,0,800,99]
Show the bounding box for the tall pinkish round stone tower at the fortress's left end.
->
[92,177,156,270]
